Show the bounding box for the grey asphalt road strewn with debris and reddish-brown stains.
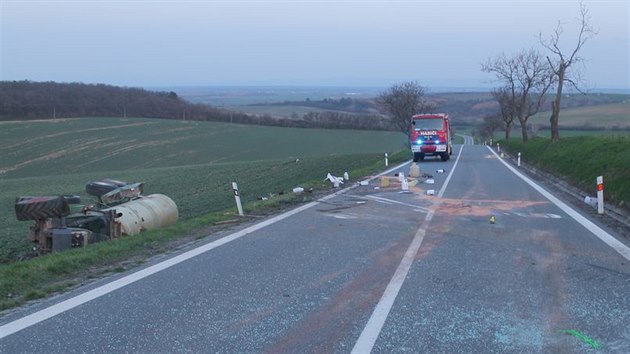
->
[0,145,630,353]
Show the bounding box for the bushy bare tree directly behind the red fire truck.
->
[376,81,435,141]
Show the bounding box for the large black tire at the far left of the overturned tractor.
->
[15,196,70,221]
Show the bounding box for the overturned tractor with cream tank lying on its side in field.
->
[15,179,179,253]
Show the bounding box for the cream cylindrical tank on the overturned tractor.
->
[104,194,179,235]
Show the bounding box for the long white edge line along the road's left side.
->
[0,161,409,339]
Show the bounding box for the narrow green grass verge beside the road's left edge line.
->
[0,150,410,311]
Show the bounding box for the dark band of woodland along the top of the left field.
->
[0,81,392,130]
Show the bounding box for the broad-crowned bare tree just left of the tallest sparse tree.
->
[481,49,553,142]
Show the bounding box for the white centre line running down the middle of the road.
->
[352,145,464,354]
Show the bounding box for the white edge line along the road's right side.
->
[486,146,630,260]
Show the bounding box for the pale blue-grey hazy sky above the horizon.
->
[0,0,630,90]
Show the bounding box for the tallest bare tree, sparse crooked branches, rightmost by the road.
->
[539,1,597,141]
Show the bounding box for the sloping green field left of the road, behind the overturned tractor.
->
[0,118,405,262]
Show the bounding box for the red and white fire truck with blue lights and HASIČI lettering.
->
[410,113,453,162]
